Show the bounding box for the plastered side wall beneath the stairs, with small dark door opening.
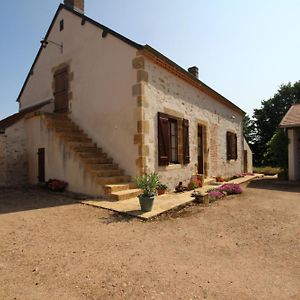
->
[26,116,104,196]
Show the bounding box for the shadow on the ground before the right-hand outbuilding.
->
[247,178,300,193]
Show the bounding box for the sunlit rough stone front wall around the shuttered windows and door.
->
[143,59,244,188]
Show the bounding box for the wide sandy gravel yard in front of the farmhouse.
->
[0,180,300,300]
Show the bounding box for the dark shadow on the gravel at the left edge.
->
[0,188,81,214]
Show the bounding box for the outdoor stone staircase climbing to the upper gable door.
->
[45,114,140,201]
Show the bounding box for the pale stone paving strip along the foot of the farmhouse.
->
[81,174,263,220]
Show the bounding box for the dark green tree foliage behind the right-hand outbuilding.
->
[248,81,300,165]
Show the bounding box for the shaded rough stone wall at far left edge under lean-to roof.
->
[0,120,28,186]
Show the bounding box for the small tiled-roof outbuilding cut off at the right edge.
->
[279,104,300,180]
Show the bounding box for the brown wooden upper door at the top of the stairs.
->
[54,68,69,113]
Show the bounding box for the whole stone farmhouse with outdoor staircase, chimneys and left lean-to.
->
[0,0,252,200]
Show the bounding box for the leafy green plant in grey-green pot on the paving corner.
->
[134,173,159,212]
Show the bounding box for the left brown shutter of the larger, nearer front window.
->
[157,113,170,166]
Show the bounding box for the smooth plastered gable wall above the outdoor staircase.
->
[20,9,138,175]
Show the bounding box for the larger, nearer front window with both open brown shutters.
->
[158,113,190,166]
